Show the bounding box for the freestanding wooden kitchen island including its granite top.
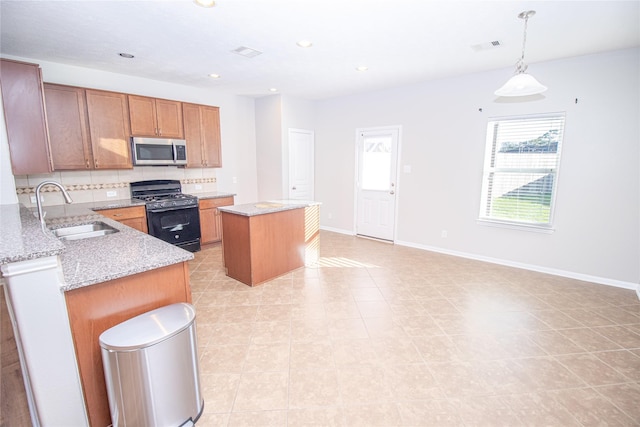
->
[219,200,320,286]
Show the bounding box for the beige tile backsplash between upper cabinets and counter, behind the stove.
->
[14,166,217,207]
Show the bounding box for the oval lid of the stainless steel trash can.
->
[99,303,196,351]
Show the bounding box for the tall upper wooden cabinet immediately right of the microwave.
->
[182,103,222,168]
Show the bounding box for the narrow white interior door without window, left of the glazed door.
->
[289,129,314,200]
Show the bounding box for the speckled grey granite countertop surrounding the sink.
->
[0,199,194,291]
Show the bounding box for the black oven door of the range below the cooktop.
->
[147,206,200,252]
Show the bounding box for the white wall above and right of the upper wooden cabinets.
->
[0,57,257,203]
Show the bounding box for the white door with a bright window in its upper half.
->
[356,128,400,241]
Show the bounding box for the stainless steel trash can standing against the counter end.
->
[100,303,204,427]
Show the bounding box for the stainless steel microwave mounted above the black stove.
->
[131,137,187,166]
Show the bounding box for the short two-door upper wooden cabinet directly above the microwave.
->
[128,95,184,139]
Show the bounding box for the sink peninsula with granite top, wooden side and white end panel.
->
[0,200,193,426]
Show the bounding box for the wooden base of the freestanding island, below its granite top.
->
[222,208,305,286]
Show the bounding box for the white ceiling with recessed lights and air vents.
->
[0,0,640,99]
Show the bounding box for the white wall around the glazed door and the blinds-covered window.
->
[316,49,640,287]
